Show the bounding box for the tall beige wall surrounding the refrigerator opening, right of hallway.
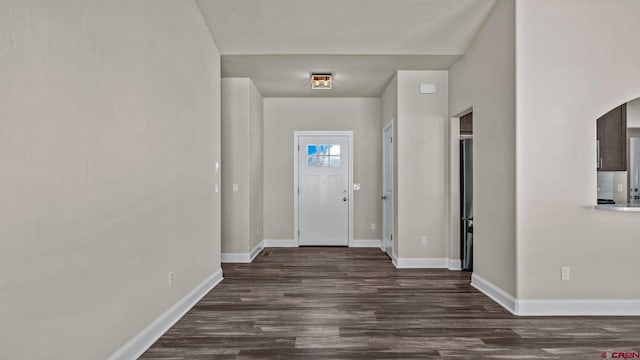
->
[449,0,516,296]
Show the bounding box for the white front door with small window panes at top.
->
[298,135,351,246]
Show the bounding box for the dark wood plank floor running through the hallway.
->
[142,248,640,360]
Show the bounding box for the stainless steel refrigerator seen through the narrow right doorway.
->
[460,139,473,271]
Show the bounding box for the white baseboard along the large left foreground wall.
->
[109,270,223,360]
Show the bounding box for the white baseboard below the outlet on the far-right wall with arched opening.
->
[516,300,640,316]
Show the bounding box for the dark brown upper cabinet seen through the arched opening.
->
[596,104,627,171]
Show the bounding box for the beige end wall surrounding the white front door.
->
[263,98,382,239]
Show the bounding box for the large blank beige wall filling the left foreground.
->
[0,0,220,360]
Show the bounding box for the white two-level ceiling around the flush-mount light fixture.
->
[197,0,496,97]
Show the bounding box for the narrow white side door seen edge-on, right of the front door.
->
[382,124,393,257]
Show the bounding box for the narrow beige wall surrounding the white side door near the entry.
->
[380,74,398,256]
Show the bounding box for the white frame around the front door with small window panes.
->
[293,131,353,247]
